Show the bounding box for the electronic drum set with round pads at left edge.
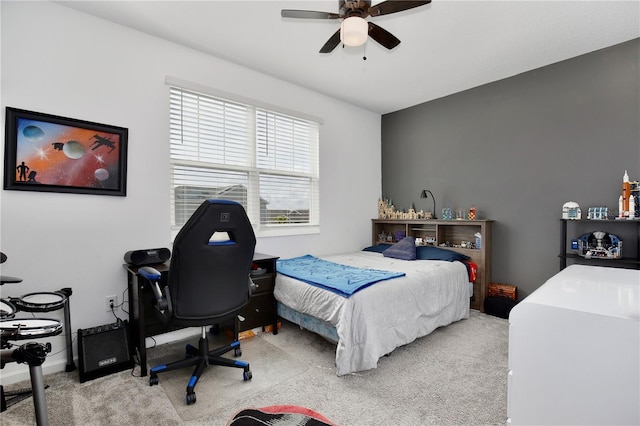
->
[0,253,75,426]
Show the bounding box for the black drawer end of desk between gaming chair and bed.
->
[239,253,278,334]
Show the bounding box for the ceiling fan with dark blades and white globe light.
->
[280,0,431,53]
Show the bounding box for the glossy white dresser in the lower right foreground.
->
[507,264,640,425]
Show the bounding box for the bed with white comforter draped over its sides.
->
[274,243,472,376]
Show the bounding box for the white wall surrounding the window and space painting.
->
[0,2,381,383]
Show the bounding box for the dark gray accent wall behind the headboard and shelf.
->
[382,39,640,299]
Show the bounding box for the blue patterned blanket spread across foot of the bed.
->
[276,254,405,297]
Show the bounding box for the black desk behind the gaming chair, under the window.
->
[123,253,278,376]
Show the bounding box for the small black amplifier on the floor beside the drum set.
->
[78,320,133,383]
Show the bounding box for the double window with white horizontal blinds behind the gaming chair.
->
[170,87,319,235]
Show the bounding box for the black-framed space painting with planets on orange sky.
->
[4,107,129,196]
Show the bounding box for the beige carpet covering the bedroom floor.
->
[0,311,508,426]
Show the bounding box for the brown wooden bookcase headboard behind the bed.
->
[371,219,493,312]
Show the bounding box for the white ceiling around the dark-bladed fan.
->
[58,0,640,114]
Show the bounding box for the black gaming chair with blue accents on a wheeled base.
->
[138,200,256,405]
